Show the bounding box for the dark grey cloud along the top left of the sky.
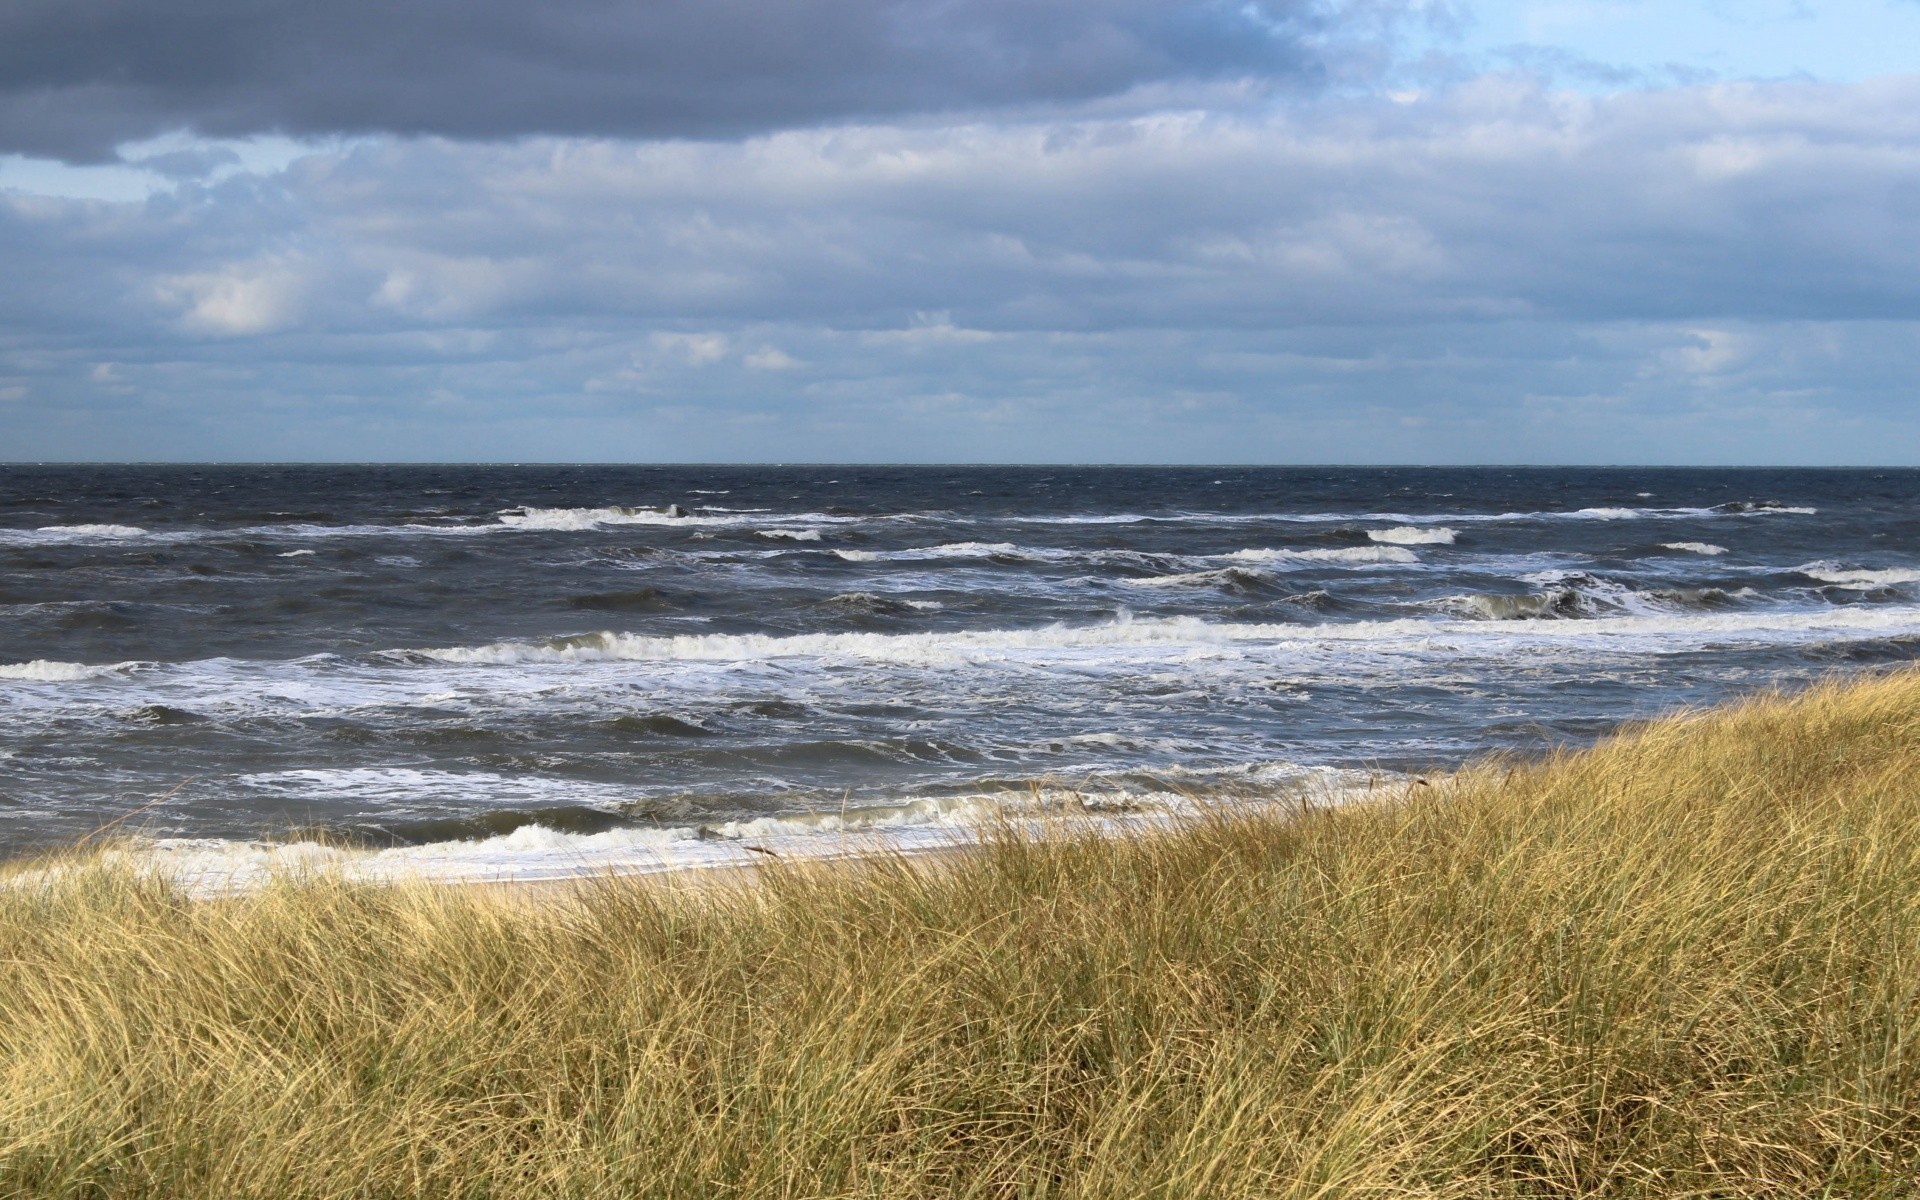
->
[0,0,1351,161]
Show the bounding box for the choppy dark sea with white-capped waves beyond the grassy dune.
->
[0,467,1920,871]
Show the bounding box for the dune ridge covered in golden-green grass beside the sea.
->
[0,672,1920,1198]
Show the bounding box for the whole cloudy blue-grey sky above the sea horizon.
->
[0,0,1920,465]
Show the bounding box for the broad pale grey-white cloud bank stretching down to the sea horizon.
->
[0,77,1920,461]
